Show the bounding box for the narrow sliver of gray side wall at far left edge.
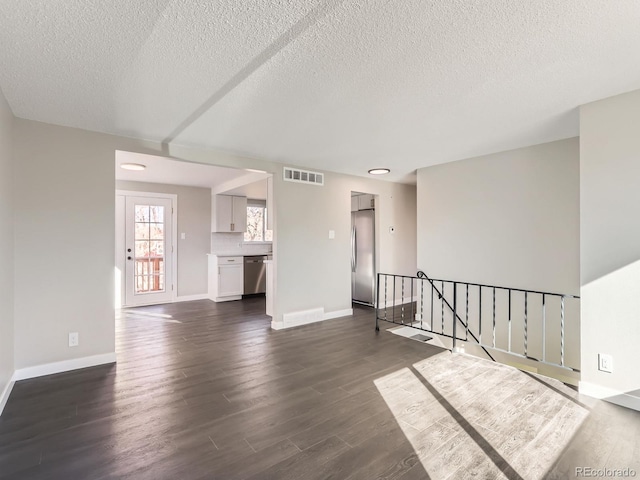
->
[0,91,14,402]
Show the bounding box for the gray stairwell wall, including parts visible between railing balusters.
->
[418,138,580,374]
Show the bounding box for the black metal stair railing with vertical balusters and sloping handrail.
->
[376,271,580,371]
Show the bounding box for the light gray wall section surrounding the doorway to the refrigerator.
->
[274,172,416,321]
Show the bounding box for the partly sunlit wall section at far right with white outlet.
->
[580,90,640,396]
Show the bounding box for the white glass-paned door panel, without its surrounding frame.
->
[123,196,173,307]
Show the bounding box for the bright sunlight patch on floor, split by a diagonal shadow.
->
[374,352,589,480]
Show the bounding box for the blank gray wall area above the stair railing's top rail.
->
[418,138,580,295]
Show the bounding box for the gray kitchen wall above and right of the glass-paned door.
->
[116,180,211,296]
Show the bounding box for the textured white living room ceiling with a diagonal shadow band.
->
[0,0,640,181]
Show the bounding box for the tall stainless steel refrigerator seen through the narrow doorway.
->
[351,210,376,305]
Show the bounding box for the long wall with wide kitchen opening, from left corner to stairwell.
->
[14,120,415,369]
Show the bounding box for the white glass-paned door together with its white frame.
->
[116,191,177,307]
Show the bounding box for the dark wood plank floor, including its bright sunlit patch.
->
[0,298,640,480]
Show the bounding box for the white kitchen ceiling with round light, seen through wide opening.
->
[115,151,270,200]
